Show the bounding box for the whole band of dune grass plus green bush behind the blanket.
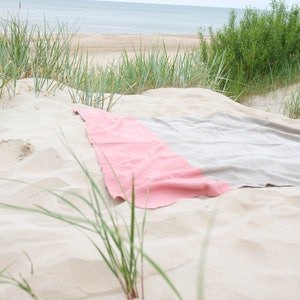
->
[0,0,300,113]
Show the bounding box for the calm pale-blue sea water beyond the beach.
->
[0,0,243,34]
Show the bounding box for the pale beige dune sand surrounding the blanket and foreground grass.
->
[0,36,300,300]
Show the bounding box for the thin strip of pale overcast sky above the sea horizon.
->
[102,0,300,9]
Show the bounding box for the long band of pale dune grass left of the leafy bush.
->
[0,16,226,110]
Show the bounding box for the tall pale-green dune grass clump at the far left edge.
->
[0,16,72,96]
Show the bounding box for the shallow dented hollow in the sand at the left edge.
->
[0,139,33,169]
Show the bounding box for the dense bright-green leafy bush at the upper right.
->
[199,0,300,99]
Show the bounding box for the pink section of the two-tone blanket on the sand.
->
[75,109,231,208]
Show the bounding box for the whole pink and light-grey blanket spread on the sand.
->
[76,109,300,208]
